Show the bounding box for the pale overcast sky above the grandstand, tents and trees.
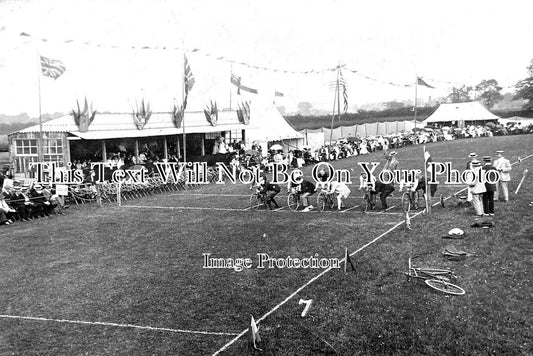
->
[0,0,533,116]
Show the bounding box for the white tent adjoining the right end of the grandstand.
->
[246,104,304,151]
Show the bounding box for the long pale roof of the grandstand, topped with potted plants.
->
[9,110,246,140]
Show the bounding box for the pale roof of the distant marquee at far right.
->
[424,101,499,124]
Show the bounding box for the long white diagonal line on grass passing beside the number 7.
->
[213,154,533,356]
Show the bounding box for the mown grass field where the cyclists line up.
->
[0,135,533,355]
